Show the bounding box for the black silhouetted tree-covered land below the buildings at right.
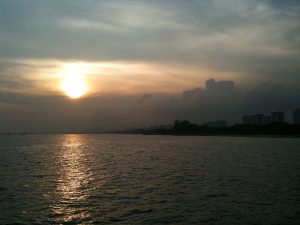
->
[132,120,300,137]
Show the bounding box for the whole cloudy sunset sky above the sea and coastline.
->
[0,0,300,132]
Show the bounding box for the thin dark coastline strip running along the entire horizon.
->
[0,120,300,138]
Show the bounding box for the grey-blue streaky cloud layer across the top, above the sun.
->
[0,0,300,83]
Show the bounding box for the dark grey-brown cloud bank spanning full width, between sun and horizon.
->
[0,79,300,132]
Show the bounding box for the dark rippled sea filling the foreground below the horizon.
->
[0,135,300,225]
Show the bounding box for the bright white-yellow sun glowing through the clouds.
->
[60,64,88,98]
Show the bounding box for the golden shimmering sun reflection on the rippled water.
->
[52,135,93,223]
